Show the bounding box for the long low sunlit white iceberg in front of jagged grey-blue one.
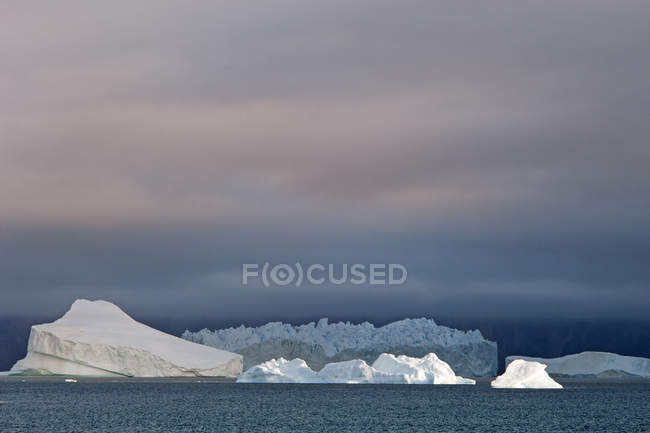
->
[237,353,475,385]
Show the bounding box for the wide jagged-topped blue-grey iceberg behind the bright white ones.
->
[182,318,497,377]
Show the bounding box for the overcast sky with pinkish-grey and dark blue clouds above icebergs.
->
[0,0,650,322]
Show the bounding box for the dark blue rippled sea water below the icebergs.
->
[0,378,650,433]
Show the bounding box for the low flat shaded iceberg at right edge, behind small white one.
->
[506,352,650,377]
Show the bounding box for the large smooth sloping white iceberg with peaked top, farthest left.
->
[10,300,243,377]
